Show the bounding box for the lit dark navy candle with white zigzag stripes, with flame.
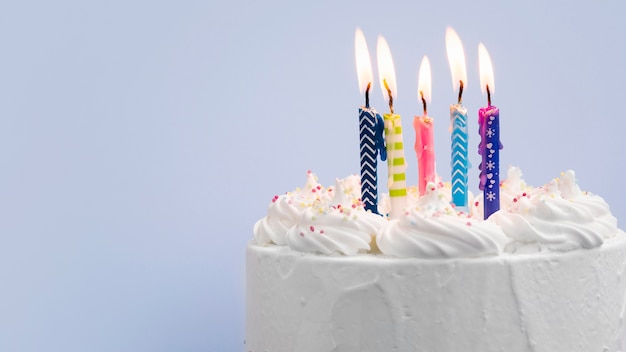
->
[354,28,387,214]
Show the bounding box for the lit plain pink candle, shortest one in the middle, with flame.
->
[413,56,435,196]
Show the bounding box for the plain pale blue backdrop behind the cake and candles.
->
[0,0,626,351]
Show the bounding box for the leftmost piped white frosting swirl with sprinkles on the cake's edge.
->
[254,171,332,246]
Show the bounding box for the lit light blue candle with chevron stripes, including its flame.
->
[446,27,471,208]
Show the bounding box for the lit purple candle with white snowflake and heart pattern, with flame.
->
[478,43,502,219]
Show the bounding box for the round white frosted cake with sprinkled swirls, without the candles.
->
[245,168,626,352]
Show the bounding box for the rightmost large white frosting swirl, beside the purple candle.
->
[489,170,618,252]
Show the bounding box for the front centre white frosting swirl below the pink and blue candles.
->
[376,183,508,259]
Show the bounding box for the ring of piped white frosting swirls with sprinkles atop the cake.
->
[254,167,619,259]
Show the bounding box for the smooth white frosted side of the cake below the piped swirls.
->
[246,231,626,352]
